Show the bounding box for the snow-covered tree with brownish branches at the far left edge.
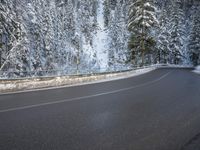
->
[0,0,26,74]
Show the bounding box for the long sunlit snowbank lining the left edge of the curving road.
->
[0,65,158,93]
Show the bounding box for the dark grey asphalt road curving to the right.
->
[0,69,200,150]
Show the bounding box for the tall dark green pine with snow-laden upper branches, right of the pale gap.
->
[128,0,158,65]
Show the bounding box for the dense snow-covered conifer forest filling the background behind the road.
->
[0,0,200,78]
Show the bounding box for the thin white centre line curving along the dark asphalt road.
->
[0,71,172,113]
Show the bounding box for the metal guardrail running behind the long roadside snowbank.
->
[0,65,165,81]
